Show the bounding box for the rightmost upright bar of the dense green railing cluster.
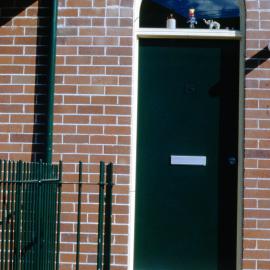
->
[56,161,63,270]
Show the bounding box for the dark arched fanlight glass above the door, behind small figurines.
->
[139,0,240,30]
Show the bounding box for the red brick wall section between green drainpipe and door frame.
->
[54,0,132,269]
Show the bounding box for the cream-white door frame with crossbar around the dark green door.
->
[128,0,246,270]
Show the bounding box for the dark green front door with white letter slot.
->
[134,39,239,270]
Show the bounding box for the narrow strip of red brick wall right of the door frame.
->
[243,0,270,269]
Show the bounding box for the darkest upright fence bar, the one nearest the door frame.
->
[103,163,113,270]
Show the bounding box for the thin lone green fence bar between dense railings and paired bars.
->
[76,161,82,270]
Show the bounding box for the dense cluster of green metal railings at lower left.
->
[0,161,61,270]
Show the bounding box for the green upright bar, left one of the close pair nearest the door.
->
[97,161,105,270]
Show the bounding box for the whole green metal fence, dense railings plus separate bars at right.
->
[0,160,113,270]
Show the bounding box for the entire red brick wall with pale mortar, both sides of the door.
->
[0,0,270,270]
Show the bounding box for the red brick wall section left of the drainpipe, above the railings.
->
[0,1,46,160]
